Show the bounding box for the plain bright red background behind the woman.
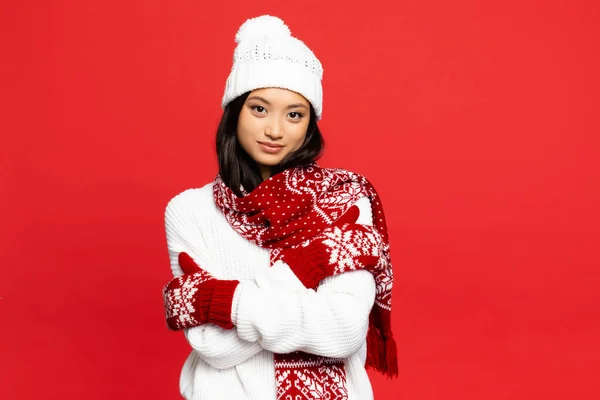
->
[0,0,600,400]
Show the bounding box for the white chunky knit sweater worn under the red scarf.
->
[165,183,375,400]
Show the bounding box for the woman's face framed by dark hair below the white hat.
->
[237,88,310,179]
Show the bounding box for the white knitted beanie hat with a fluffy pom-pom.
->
[221,15,323,120]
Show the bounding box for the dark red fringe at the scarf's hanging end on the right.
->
[366,324,398,378]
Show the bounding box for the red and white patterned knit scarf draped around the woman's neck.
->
[213,163,398,400]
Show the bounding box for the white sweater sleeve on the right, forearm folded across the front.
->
[232,198,376,358]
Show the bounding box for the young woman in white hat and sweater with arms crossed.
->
[163,16,397,400]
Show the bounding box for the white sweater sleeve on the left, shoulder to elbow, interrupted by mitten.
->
[165,189,262,369]
